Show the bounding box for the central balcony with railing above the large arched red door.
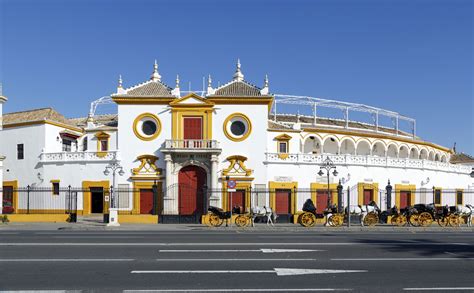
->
[161,139,222,154]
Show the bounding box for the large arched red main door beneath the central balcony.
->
[178,166,207,215]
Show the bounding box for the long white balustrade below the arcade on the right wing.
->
[265,153,471,174]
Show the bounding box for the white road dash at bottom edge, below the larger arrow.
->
[123,288,352,293]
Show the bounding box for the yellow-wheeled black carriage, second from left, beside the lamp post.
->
[298,199,344,227]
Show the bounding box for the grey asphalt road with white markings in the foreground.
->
[0,230,474,292]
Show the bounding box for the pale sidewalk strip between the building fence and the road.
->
[0,222,474,233]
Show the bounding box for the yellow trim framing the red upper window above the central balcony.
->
[171,107,212,140]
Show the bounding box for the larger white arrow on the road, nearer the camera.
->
[130,268,367,276]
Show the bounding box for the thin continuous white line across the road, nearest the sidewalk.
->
[0,242,468,246]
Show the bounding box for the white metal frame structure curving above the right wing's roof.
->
[272,94,416,137]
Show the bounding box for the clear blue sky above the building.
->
[0,0,474,154]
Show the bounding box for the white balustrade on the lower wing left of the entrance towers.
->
[40,151,118,163]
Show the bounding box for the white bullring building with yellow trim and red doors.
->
[0,62,474,222]
